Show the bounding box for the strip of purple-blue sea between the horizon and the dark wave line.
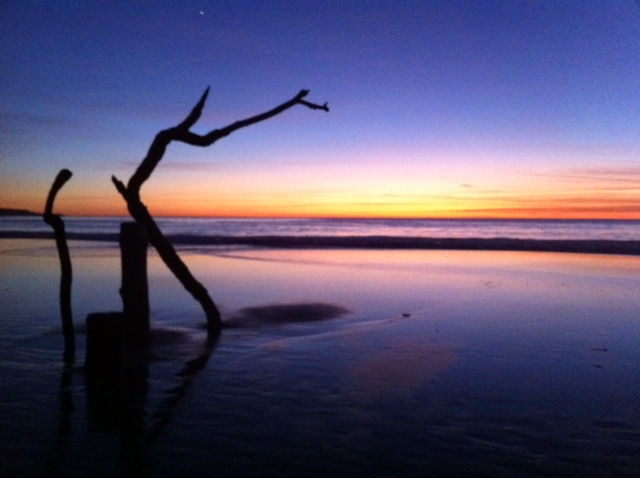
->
[0,217,640,242]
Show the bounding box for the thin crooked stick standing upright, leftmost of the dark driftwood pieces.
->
[42,169,76,363]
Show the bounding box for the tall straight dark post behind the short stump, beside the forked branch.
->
[120,222,149,344]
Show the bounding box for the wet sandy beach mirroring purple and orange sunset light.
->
[0,239,640,476]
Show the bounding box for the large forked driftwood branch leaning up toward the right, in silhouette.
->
[111,88,329,334]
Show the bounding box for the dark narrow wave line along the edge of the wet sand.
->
[0,231,640,256]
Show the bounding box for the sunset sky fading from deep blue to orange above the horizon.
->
[0,0,640,219]
